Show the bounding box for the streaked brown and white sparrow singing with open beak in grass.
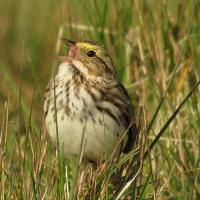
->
[44,39,137,162]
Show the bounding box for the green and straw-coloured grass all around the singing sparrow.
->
[0,0,200,200]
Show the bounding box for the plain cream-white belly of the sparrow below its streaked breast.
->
[46,106,127,160]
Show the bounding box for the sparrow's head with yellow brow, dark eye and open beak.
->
[63,39,115,79]
